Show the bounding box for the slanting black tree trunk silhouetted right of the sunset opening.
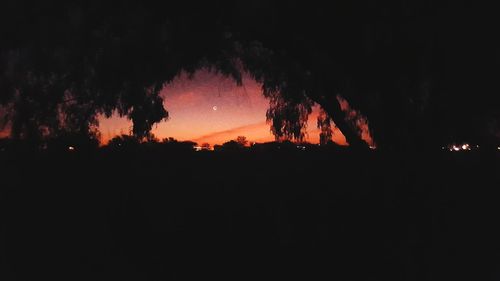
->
[319,96,369,149]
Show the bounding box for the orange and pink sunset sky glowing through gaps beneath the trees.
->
[96,70,345,145]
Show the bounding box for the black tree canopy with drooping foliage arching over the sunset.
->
[0,0,500,148]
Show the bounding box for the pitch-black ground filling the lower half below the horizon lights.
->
[0,151,500,280]
